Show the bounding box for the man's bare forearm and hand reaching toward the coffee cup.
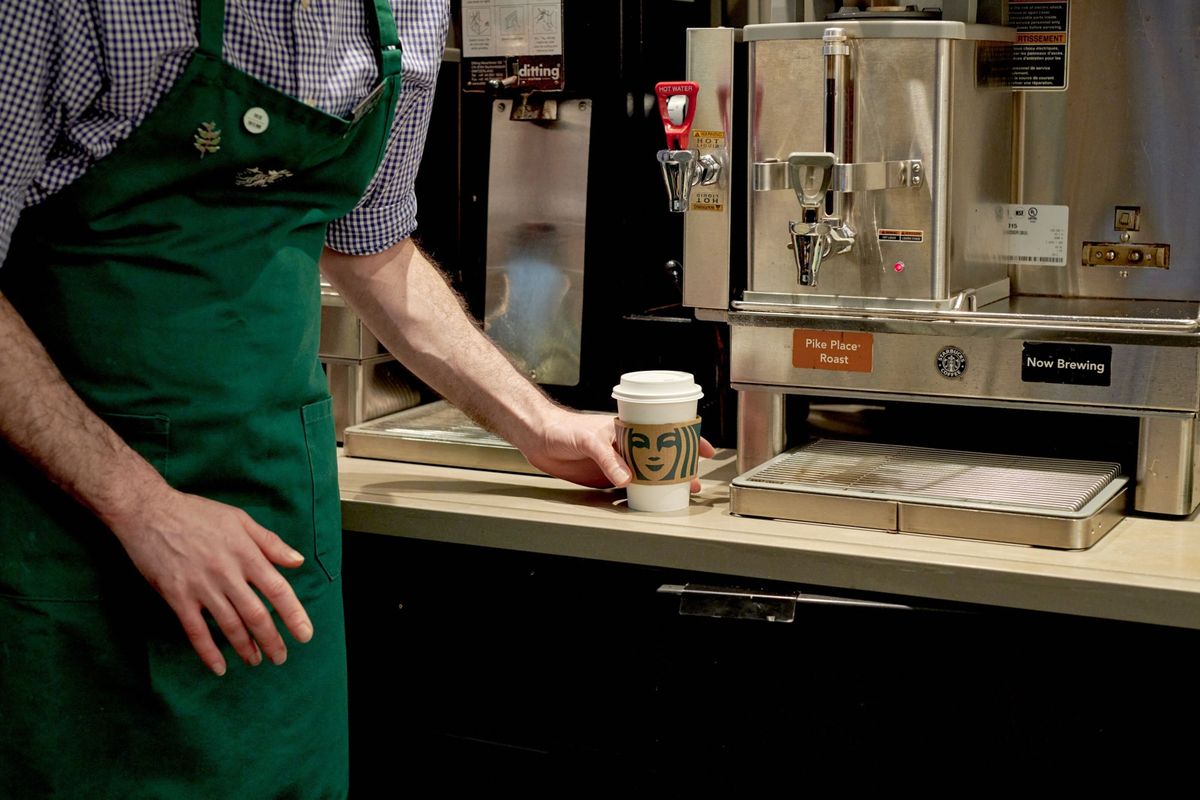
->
[320,239,638,487]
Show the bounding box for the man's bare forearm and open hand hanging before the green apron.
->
[0,295,312,675]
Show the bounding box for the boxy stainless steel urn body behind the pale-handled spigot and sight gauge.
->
[745,22,1013,302]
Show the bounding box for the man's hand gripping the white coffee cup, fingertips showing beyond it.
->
[523,408,714,492]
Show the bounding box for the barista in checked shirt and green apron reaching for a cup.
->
[0,0,657,798]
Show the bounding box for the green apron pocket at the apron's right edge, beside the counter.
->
[300,397,342,581]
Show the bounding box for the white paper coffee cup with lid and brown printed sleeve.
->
[612,369,704,511]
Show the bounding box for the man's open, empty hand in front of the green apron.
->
[109,487,312,675]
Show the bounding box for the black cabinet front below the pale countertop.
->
[344,533,1200,794]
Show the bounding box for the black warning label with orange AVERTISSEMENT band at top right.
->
[1008,0,1070,91]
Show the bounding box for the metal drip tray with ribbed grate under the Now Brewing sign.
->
[730,439,1129,549]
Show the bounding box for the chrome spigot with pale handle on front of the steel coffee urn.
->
[787,152,854,287]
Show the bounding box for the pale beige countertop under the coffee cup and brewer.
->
[338,451,1200,628]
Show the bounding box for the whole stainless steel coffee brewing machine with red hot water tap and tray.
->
[659,0,1200,548]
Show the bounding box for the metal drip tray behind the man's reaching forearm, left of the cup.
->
[343,401,541,475]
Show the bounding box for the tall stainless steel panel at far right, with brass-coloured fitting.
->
[1014,0,1200,300]
